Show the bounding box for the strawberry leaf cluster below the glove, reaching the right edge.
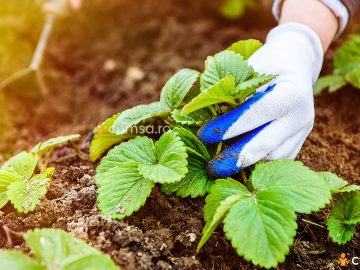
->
[198,160,360,268]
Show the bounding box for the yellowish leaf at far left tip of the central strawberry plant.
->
[89,113,134,162]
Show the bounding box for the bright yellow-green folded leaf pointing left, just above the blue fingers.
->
[181,75,236,115]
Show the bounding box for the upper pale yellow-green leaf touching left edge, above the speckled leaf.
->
[1,151,38,179]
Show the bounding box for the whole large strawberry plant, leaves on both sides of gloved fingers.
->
[90,40,358,268]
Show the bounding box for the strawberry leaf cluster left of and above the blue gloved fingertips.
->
[90,40,274,219]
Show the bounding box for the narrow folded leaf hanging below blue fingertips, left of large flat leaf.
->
[197,178,251,251]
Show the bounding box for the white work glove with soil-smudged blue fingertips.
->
[198,23,323,177]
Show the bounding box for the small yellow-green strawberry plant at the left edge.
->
[0,134,79,213]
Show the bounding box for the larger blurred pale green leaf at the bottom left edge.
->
[25,229,119,270]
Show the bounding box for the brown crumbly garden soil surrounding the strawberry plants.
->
[0,0,360,270]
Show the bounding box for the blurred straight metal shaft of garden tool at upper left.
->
[30,13,57,70]
